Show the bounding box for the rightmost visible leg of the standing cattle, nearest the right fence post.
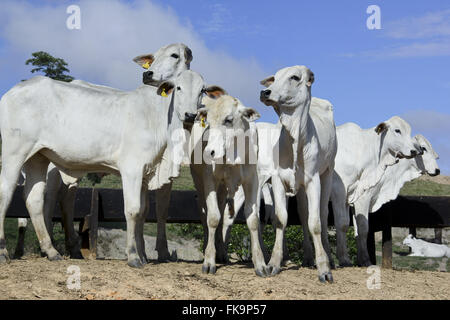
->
[355,201,372,267]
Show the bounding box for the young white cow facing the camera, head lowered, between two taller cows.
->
[191,91,269,276]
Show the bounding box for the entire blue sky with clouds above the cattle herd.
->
[0,0,450,174]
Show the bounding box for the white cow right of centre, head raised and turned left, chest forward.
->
[258,66,337,282]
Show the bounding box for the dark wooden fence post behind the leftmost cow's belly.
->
[80,188,99,259]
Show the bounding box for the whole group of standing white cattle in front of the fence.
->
[0,44,439,282]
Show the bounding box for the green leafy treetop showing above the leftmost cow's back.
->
[25,51,74,82]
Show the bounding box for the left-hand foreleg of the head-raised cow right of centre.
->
[268,176,288,275]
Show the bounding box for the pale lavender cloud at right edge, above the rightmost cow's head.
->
[402,110,450,175]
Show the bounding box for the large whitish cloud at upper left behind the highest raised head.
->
[0,0,266,109]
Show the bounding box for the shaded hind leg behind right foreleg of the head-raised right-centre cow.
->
[320,169,335,269]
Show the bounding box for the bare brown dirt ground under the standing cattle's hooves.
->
[0,257,450,300]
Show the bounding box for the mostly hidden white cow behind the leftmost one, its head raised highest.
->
[15,43,192,261]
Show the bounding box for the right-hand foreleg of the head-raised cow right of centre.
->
[305,174,333,282]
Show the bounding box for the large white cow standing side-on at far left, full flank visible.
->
[0,71,207,267]
